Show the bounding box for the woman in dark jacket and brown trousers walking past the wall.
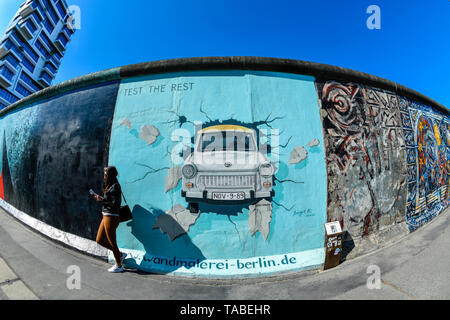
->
[93,166,126,273]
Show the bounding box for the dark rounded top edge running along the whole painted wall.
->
[0,56,449,117]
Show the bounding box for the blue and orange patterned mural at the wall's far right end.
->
[399,98,450,230]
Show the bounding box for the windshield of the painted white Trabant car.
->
[197,131,255,152]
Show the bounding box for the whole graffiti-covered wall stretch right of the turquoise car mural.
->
[316,80,450,237]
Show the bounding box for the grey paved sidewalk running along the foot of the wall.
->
[0,205,450,300]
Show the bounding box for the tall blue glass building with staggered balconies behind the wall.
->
[0,0,75,109]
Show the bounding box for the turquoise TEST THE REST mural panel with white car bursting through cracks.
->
[109,70,326,276]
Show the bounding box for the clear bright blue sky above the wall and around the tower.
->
[0,0,450,107]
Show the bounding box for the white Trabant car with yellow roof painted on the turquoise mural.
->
[181,125,274,213]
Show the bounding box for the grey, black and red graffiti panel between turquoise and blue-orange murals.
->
[316,81,406,237]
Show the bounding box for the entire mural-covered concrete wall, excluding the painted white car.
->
[0,57,450,277]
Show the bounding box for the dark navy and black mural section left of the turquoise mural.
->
[0,82,118,240]
